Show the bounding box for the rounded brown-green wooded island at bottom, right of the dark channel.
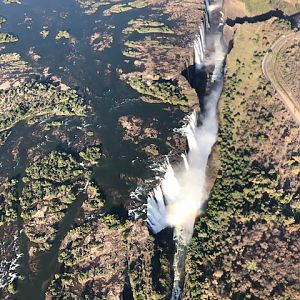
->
[47,218,125,299]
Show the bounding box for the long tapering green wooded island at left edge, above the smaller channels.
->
[0,81,86,131]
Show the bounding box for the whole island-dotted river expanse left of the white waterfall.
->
[0,0,204,299]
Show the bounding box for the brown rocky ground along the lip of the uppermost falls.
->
[120,0,204,108]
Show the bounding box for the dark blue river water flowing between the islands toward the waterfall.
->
[0,0,184,300]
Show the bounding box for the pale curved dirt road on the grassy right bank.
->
[262,31,300,125]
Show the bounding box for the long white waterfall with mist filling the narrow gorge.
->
[147,0,226,300]
